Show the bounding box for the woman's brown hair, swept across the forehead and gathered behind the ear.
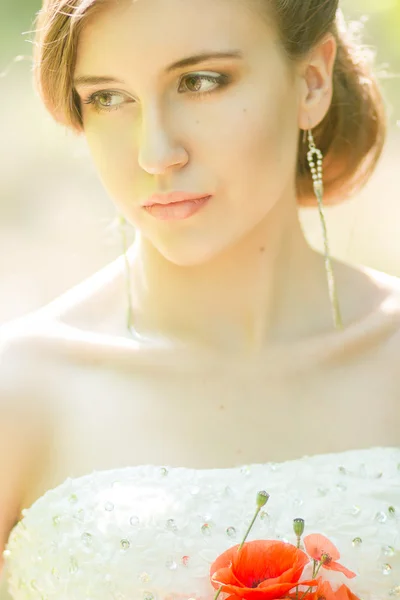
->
[33,0,387,206]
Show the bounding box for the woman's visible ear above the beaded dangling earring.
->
[298,33,337,130]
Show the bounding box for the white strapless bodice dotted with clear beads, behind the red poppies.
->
[4,448,400,600]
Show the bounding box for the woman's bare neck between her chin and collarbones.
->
[127,203,333,354]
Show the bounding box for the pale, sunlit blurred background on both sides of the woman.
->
[0,0,400,324]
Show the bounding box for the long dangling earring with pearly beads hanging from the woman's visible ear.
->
[304,129,343,329]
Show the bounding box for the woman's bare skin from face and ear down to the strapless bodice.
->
[0,0,400,569]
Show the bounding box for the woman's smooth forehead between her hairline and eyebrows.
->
[75,0,277,74]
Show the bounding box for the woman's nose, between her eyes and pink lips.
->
[138,107,188,175]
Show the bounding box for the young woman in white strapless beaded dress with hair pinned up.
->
[0,0,400,600]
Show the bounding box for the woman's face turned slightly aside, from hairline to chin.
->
[75,0,298,265]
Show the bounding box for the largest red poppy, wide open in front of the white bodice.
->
[210,540,317,600]
